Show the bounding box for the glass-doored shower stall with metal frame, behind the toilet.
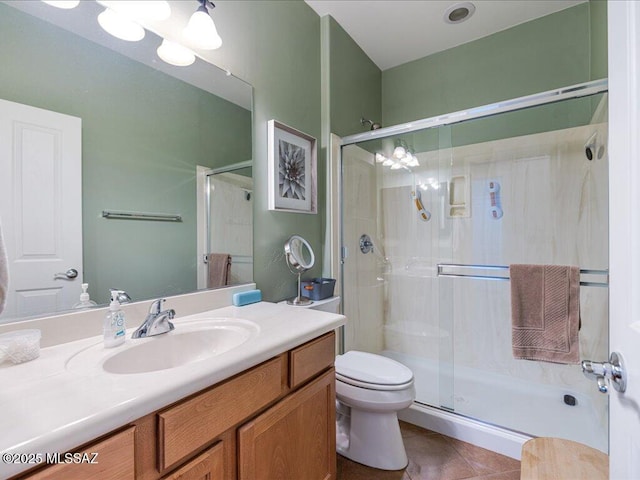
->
[336,81,608,457]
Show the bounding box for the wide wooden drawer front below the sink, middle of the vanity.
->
[158,356,286,471]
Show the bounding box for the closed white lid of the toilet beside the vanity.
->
[335,350,413,385]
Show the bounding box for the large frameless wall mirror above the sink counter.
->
[0,0,253,323]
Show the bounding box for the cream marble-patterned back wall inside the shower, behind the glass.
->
[377,120,608,431]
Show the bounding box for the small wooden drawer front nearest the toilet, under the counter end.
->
[289,332,336,388]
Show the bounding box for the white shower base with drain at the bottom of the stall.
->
[382,350,608,459]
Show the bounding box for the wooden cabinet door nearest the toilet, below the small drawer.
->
[238,368,336,480]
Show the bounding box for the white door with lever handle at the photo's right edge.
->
[603,0,640,480]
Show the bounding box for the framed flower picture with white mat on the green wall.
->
[267,120,318,214]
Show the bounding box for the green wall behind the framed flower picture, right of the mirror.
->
[194,0,326,301]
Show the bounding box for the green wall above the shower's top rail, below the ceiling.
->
[382,3,606,125]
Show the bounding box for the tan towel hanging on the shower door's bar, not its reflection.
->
[509,265,580,363]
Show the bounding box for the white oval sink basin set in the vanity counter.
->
[66,318,260,375]
